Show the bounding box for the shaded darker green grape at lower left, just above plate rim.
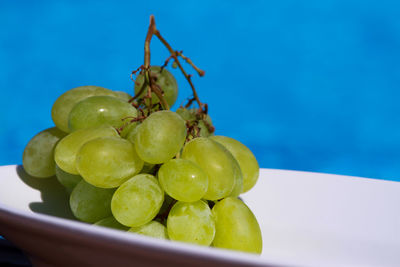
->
[69,180,115,223]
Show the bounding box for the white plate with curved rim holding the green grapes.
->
[0,166,400,266]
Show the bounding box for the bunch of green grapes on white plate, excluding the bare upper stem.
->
[23,67,262,253]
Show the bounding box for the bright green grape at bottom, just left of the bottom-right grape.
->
[167,200,215,246]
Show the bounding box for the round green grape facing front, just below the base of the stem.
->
[133,110,186,164]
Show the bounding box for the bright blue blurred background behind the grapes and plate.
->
[0,0,400,181]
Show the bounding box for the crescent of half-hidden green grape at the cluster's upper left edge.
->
[51,85,116,133]
